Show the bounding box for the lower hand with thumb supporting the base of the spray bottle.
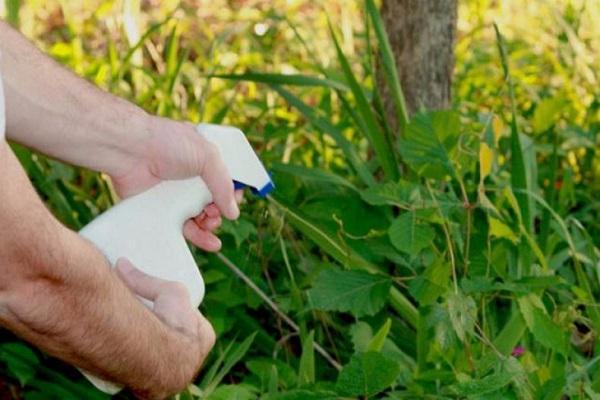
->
[116,258,215,398]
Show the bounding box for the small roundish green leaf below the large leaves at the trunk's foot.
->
[388,211,435,257]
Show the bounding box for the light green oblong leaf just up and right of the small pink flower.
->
[517,294,568,355]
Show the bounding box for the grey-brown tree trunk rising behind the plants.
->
[379,0,457,122]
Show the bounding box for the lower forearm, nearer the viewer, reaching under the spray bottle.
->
[0,143,200,392]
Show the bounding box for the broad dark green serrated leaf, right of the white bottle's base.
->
[308,269,392,317]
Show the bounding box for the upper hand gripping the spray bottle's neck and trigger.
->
[111,116,242,251]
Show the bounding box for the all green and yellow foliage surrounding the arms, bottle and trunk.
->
[0,0,600,399]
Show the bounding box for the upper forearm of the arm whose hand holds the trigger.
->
[0,21,153,175]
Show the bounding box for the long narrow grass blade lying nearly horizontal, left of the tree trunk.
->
[210,72,348,91]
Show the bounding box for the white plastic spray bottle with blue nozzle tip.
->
[79,124,274,394]
